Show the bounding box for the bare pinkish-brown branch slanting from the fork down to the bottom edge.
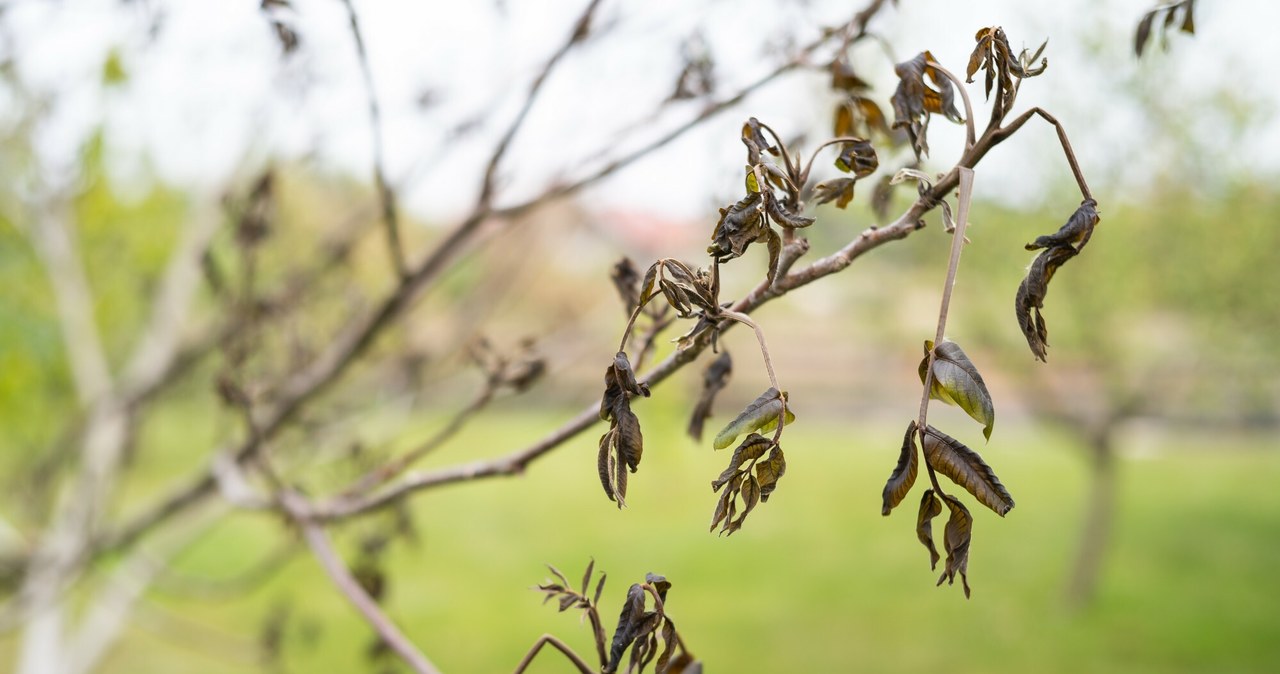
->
[280,491,439,674]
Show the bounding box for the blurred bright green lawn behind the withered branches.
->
[12,405,1280,674]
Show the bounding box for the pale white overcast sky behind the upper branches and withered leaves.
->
[0,0,1280,217]
